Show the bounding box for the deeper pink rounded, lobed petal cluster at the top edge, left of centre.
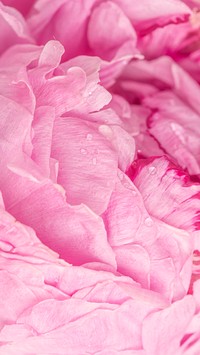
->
[28,0,137,59]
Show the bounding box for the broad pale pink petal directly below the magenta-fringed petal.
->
[103,171,193,300]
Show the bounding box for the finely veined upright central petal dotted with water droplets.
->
[52,117,118,214]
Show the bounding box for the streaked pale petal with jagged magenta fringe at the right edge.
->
[131,157,200,231]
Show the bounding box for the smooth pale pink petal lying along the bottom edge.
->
[0,301,166,354]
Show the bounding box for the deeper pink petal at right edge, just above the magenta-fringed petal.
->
[144,91,200,175]
